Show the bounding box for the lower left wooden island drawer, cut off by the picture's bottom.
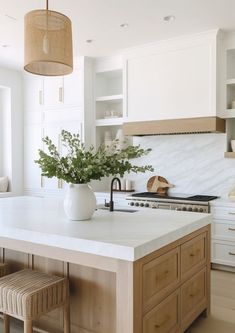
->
[143,290,180,333]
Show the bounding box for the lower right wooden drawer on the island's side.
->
[181,268,207,330]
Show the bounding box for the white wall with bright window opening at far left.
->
[0,67,23,195]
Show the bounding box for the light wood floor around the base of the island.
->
[0,270,235,333]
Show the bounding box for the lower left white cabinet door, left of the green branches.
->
[24,124,42,189]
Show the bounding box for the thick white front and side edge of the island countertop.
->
[1,215,211,262]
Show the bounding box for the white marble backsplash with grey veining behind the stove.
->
[128,134,235,197]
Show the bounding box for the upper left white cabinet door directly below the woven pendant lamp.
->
[24,74,44,111]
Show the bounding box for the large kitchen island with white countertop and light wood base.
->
[0,197,211,333]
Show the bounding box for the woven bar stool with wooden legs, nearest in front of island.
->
[0,269,70,333]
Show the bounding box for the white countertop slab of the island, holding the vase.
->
[0,197,211,261]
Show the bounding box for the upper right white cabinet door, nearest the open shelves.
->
[64,69,83,106]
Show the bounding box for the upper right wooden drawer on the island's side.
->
[181,232,207,280]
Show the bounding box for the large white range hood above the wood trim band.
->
[126,32,216,121]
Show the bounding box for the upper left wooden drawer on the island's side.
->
[143,247,180,310]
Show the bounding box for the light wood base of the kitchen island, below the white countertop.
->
[0,225,210,333]
